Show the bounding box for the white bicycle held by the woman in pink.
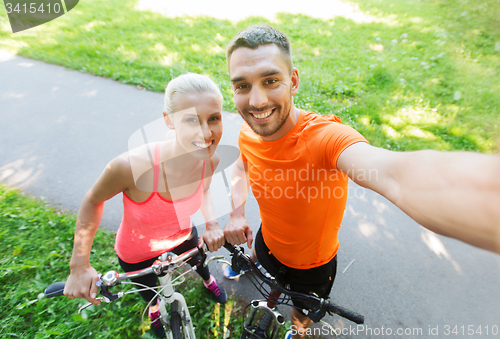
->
[44,248,223,339]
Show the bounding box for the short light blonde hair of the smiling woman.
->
[163,73,224,114]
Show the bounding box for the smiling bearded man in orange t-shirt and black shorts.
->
[224,26,500,338]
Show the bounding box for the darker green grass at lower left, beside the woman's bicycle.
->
[0,185,242,339]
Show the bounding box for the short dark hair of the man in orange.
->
[226,25,293,72]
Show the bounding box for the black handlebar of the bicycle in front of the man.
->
[224,242,365,324]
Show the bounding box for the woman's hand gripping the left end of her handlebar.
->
[64,266,101,305]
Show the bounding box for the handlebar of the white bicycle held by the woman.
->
[43,247,207,300]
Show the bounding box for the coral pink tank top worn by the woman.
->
[115,143,205,264]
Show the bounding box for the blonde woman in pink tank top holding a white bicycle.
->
[64,73,226,338]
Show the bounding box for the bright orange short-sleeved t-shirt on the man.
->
[239,110,367,269]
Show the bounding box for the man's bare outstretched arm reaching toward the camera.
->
[337,143,500,253]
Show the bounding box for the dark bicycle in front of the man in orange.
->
[219,243,364,339]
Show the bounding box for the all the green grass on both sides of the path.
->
[0,0,500,339]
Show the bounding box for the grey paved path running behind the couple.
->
[0,52,500,338]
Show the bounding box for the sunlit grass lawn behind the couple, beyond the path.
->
[0,0,500,153]
